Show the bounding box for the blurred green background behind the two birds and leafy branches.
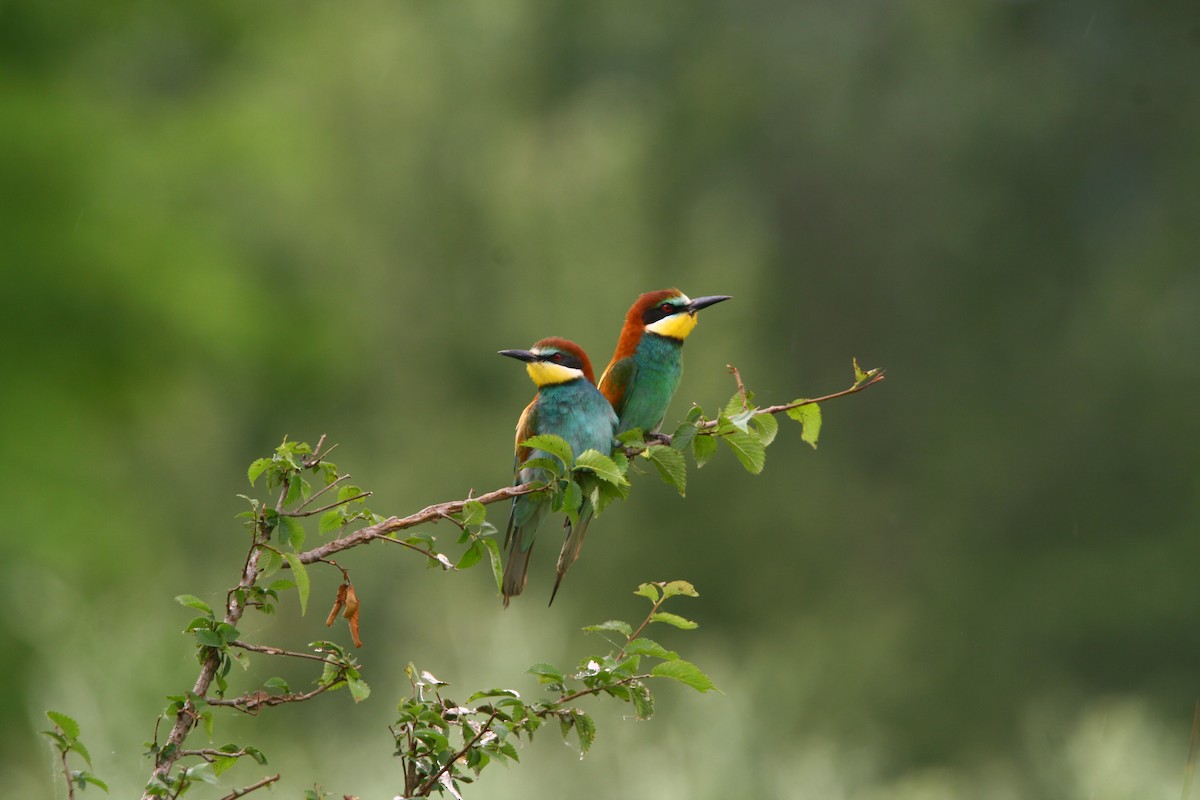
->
[0,0,1200,799]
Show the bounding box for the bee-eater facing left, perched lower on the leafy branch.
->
[499,337,618,607]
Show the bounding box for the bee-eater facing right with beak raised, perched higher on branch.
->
[600,289,730,434]
